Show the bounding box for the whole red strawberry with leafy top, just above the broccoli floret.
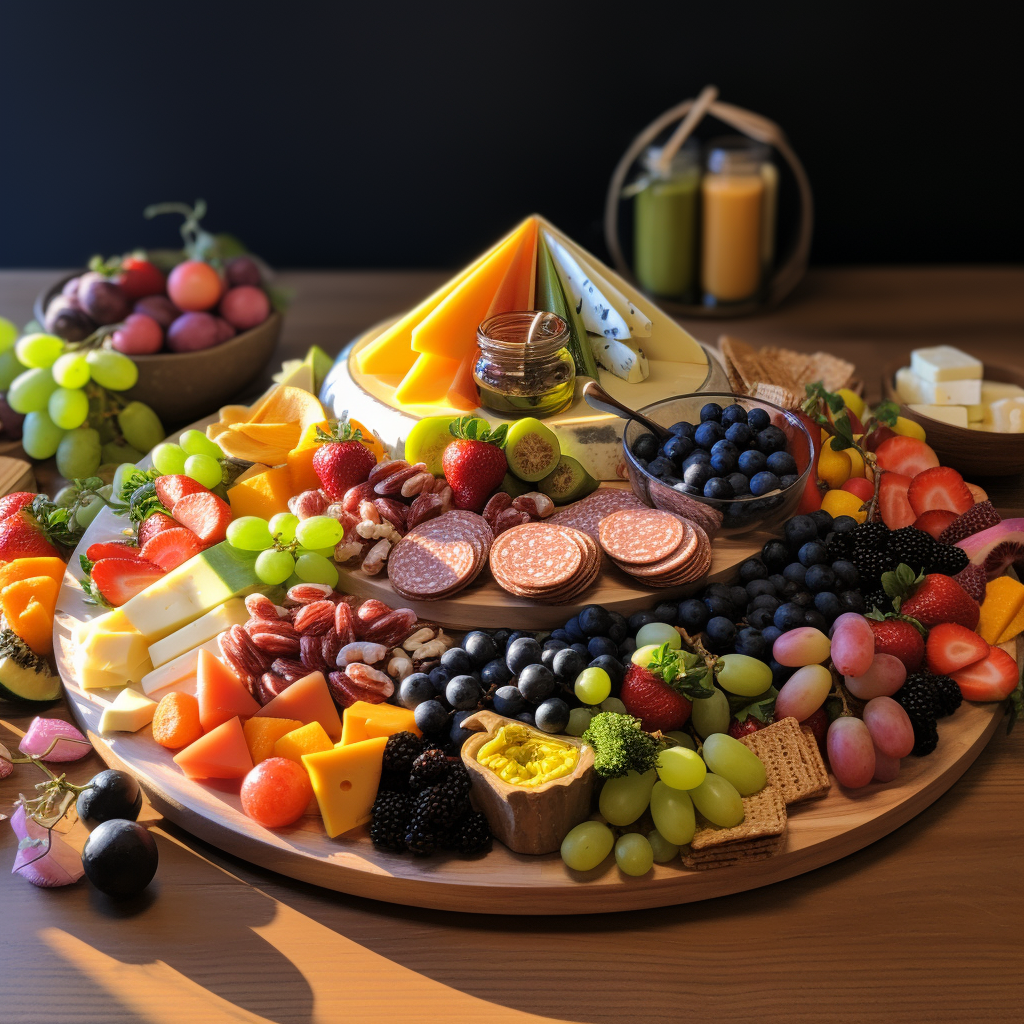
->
[618,643,712,732]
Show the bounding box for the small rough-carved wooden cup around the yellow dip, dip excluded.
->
[462,711,595,854]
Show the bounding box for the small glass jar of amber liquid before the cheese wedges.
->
[473,310,575,418]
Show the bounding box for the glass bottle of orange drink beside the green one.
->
[700,138,768,303]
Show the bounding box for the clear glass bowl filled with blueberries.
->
[623,391,811,536]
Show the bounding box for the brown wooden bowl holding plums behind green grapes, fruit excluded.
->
[34,270,284,430]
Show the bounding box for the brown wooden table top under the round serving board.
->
[0,268,1024,1024]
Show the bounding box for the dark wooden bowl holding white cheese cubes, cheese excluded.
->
[882,359,1024,480]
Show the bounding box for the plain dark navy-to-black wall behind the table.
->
[0,0,1024,267]
